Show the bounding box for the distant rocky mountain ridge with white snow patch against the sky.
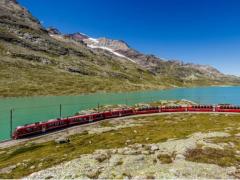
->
[80,36,225,78]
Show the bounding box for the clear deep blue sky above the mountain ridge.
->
[18,0,240,75]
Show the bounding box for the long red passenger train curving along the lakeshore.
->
[12,105,240,139]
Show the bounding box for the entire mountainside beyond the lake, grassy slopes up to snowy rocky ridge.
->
[0,0,240,97]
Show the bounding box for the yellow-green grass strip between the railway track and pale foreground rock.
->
[0,114,240,178]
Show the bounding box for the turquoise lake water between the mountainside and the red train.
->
[0,87,240,141]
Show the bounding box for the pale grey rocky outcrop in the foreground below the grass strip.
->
[26,132,240,179]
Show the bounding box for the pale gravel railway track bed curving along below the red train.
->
[0,112,240,149]
